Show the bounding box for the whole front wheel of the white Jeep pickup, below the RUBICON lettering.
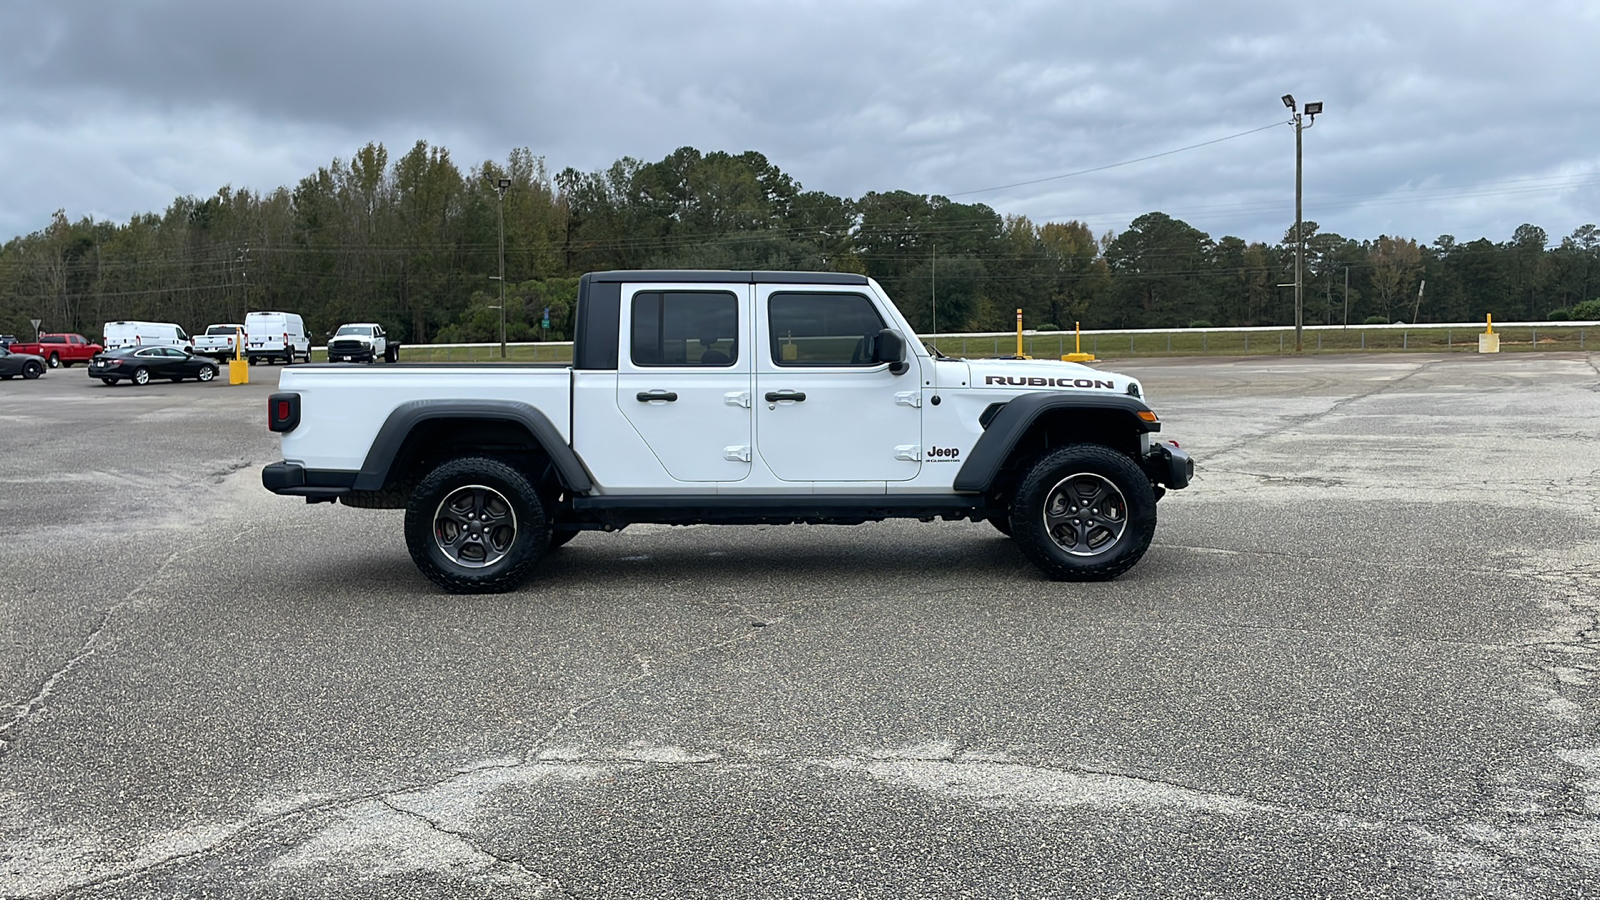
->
[1008,444,1155,581]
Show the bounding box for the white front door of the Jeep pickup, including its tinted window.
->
[755,285,922,482]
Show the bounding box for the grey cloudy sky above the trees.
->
[0,0,1600,242]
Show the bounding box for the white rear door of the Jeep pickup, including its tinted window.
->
[616,283,754,487]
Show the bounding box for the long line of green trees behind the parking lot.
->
[0,141,1600,343]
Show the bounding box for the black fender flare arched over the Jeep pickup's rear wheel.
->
[350,400,594,493]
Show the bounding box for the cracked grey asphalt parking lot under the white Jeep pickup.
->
[0,352,1600,898]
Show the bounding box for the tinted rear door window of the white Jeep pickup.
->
[632,291,739,367]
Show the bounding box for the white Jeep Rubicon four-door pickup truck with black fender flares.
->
[261,271,1194,593]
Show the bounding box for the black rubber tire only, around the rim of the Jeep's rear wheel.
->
[405,456,550,594]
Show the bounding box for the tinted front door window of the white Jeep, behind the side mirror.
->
[766,293,885,365]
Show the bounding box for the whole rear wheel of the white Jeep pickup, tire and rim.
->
[405,456,550,594]
